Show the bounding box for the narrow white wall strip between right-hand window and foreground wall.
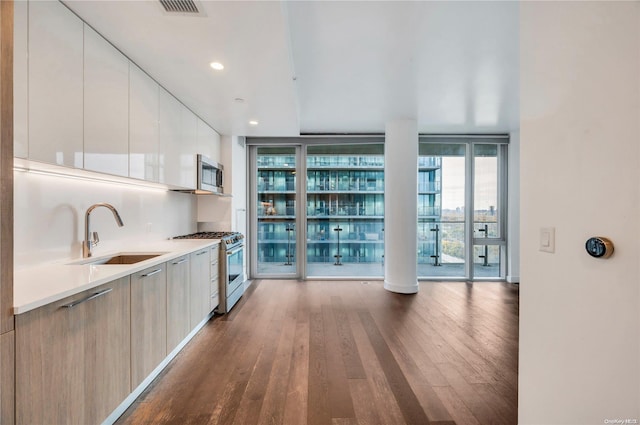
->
[507,131,520,283]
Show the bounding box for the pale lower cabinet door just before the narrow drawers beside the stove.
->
[189,248,211,329]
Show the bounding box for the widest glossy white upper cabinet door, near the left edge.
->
[29,1,83,168]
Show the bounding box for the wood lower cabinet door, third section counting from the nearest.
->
[167,255,191,353]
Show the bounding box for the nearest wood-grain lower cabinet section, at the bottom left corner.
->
[16,276,131,424]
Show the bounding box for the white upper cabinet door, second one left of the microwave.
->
[159,87,183,187]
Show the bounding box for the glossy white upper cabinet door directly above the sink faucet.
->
[84,25,129,176]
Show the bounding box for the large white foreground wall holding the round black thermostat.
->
[519,2,640,425]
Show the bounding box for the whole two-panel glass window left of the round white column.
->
[250,139,384,278]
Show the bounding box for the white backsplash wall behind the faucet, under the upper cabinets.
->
[14,171,196,268]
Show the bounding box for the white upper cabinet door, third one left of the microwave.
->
[129,62,160,182]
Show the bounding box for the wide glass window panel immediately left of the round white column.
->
[306,144,384,277]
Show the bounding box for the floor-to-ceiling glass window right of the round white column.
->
[418,136,508,279]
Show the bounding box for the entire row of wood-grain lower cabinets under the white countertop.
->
[14,247,219,425]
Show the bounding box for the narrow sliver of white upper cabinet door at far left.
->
[13,1,29,158]
